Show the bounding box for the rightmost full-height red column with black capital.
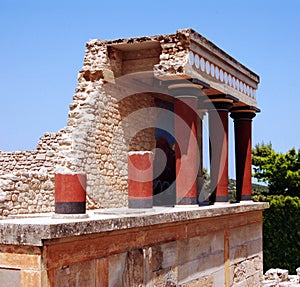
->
[230,110,255,201]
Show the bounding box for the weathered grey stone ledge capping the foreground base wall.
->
[0,202,269,246]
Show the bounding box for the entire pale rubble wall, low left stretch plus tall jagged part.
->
[0,37,162,217]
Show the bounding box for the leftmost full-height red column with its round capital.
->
[169,84,202,204]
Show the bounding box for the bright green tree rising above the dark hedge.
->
[252,143,300,196]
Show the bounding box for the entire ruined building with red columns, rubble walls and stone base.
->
[0,29,267,287]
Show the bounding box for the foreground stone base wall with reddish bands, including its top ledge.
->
[0,203,266,287]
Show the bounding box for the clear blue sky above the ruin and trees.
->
[0,0,300,159]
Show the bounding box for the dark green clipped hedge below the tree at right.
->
[254,195,300,274]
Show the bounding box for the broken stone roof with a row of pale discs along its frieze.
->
[97,28,260,107]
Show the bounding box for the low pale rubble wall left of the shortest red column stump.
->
[0,130,69,216]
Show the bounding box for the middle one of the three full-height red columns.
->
[208,99,232,203]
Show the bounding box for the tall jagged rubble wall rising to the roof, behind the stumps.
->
[64,40,155,208]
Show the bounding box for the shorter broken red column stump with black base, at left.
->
[55,173,86,214]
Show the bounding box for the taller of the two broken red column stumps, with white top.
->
[128,151,153,208]
